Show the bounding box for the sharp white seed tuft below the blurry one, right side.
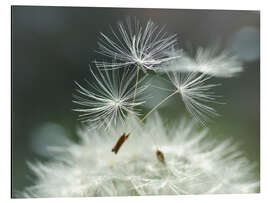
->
[168,72,219,125]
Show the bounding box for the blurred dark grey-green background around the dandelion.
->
[12,6,260,196]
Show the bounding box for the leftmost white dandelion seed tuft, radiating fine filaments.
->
[73,68,148,129]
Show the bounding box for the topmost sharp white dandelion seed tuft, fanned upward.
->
[96,18,179,71]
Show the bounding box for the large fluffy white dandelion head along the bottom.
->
[18,114,259,197]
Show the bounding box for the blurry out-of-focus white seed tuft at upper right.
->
[160,46,243,78]
